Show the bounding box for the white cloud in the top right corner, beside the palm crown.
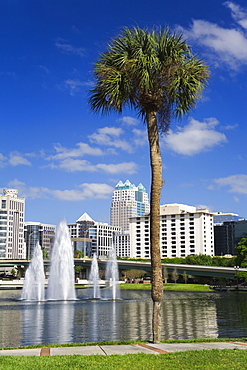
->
[179,1,247,69]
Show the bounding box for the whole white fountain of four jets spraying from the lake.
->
[21,221,119,301]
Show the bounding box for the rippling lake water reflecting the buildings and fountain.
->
[0,289,247,347]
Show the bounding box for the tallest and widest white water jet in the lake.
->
[47,221,76,300]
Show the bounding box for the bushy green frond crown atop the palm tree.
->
[89,27,209,132]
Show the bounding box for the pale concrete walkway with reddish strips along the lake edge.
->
[0,342,247,356]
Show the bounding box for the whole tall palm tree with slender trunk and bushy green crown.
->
[89,28,209,343]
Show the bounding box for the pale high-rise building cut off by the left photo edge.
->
[0,189,26,259]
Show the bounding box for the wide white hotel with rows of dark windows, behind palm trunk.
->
[130,203,214,258]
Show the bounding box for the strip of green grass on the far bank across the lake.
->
[120,283,213,292]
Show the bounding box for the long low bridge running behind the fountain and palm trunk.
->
[0,258,247,278]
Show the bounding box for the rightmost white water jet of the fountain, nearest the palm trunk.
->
[105,246,119,300]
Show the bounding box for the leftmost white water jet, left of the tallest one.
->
[21,242,45,301]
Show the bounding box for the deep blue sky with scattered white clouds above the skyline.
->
[0,0,247,224]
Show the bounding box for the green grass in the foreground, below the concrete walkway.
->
[0,349,247,370]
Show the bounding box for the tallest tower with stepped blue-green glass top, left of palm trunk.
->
[110,180,150,233]
